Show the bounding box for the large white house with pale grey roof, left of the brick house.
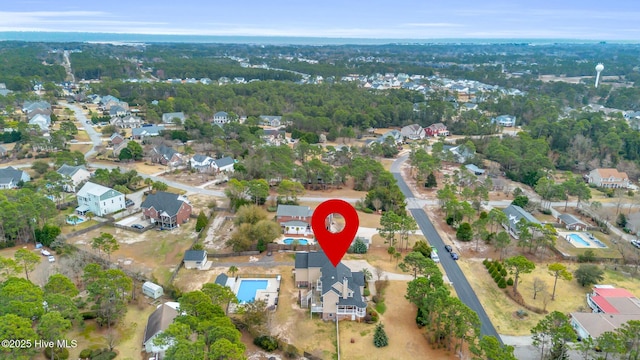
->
[76,182,126,216]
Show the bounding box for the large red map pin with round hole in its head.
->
[311,199,360,267]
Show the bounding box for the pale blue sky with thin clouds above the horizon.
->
[0,0,640,42]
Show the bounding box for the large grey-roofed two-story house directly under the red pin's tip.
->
[295,252,367,321]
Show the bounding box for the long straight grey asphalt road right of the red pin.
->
[391,155,502,343]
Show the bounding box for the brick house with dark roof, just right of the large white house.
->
[140,191,193,229]
